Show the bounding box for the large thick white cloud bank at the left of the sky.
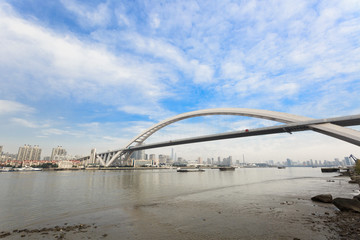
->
[0,5,172,113]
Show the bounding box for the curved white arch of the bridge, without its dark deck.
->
[97,108,360,166]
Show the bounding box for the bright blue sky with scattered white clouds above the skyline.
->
[0,0,360,162]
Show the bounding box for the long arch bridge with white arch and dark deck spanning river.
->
[80,108,360,167]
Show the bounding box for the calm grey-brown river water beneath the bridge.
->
[0,168,358,239]
